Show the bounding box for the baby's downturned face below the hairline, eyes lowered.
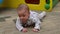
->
[18,10,30,23]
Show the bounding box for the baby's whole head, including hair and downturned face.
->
[17,4,30,23]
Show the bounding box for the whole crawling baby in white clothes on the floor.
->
[16,4,46,32]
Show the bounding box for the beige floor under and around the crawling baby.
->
[0,2,60,34]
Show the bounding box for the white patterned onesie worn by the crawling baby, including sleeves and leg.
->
[16,11,46,31]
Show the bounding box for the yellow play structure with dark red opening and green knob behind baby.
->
[0,0,59,11]
